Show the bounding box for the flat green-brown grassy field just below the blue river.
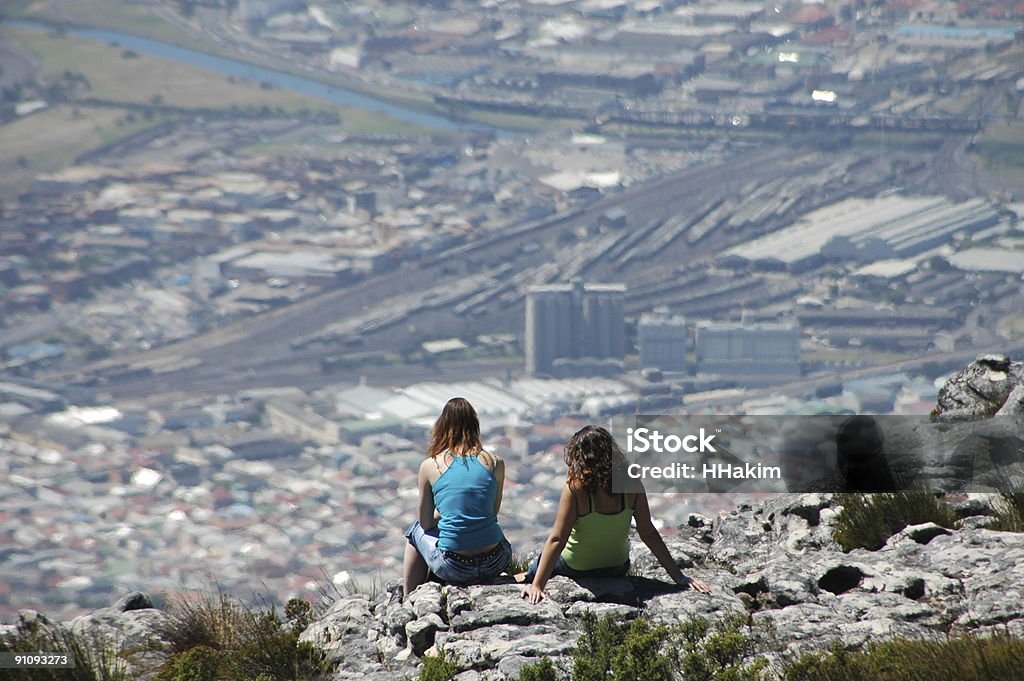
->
[0,23,433,196]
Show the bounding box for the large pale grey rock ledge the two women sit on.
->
[303,495,1024,680]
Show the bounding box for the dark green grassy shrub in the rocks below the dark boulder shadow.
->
[833,492,956,551]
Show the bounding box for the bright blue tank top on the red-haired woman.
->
[431,456,505,551]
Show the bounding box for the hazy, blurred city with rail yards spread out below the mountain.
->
[0,0,1024,621]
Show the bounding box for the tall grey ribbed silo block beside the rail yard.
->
[525,282,626,376]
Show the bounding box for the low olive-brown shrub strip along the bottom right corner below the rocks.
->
[782,636,1024,681]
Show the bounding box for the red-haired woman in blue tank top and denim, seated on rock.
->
[403,397,512,596]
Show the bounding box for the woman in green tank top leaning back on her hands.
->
[517,426,710,603]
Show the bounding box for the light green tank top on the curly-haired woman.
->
[562,494,633,569]
